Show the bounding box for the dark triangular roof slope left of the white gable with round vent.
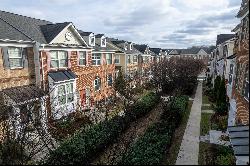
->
[41,22,70,43]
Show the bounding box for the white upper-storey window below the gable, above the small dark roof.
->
[50,51,68,68]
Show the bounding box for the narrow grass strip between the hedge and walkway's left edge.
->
[162,101,193,165]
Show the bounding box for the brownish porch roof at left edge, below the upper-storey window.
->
[2,85,45,104]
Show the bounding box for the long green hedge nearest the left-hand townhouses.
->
[45,92,159,165]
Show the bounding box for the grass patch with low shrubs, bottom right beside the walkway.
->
[198,142,235,165]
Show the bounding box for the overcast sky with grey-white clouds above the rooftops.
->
[0,0,241,48]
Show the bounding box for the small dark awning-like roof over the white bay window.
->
[49,70,77,82]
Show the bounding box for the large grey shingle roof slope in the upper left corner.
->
[0,10,51,43]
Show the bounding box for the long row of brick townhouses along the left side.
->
[0,11,210,136]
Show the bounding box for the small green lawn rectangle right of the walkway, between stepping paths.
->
[200,113,213,135]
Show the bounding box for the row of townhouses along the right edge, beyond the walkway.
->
[208,0,249,165]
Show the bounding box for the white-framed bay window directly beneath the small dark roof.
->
[58,83,74,105]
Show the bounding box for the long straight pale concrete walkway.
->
[175,82,202,165]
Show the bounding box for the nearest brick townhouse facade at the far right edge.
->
[232,0,249,125]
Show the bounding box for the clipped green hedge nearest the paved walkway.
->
[119,96,188,165]
